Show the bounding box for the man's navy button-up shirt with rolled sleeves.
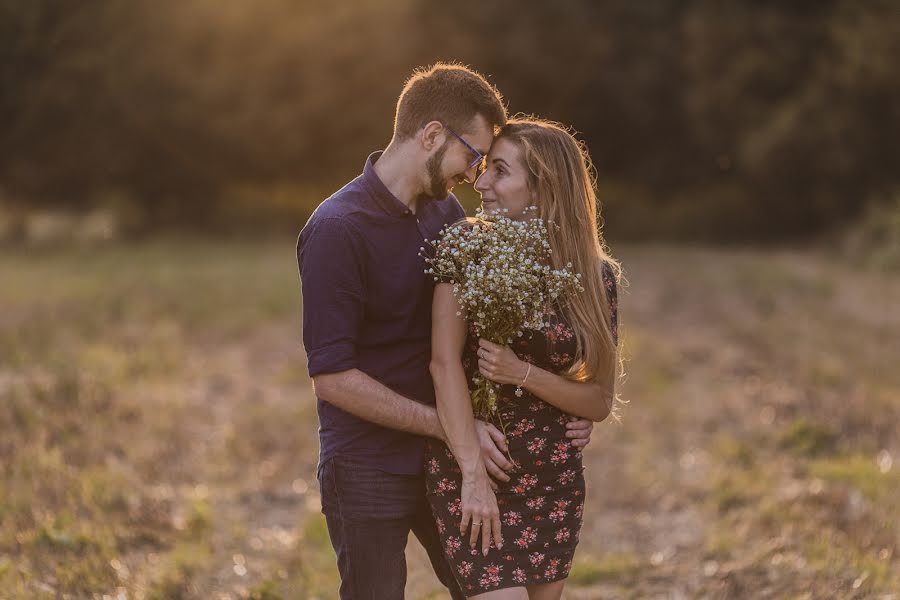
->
[297,152,465,474]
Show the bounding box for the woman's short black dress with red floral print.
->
[425,265,618,596]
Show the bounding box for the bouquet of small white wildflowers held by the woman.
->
[422,206,584,417]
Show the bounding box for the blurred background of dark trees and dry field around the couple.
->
[0,0,900,600]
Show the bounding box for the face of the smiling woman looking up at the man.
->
[475,138,533,221]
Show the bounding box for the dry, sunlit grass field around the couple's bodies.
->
[0,239,900,600]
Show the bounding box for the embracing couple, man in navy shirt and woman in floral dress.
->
[297,64,619,600]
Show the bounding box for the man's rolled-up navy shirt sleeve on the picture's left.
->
[297,218,365,377]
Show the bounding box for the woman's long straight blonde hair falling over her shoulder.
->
[497,117,622,394]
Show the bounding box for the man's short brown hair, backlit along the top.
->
[394,63,506,140]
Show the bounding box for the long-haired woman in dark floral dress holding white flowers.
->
[426,118,619,600]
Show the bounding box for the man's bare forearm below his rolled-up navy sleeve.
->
[313,369,444,440]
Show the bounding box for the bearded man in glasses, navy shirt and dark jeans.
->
[297,64,593,600]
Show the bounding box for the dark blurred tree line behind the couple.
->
[0,0,900,240]
